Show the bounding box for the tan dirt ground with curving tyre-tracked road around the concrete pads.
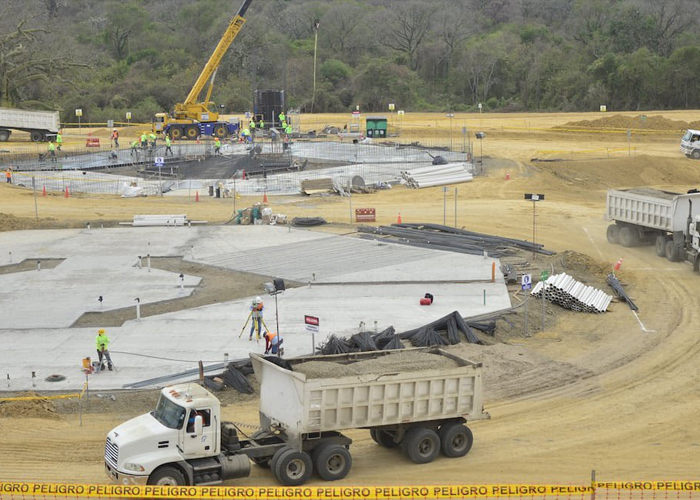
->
[0,112,700,485]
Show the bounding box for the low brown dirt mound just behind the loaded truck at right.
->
[536,155,700,190]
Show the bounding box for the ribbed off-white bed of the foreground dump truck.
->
[250,348,488,442]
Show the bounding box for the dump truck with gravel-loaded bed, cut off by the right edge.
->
[606,188,700,271]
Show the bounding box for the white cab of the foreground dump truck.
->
[105,383,220,484]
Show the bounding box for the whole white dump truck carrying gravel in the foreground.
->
[105,348,489,486]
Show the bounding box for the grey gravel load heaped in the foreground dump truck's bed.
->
[294,351,458,378]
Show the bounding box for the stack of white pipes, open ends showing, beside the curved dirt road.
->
[531,273,612,313]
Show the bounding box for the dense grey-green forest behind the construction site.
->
[0,0,700,122]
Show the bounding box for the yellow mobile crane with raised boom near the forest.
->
[153,0,253,139]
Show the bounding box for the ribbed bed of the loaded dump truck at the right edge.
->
[606,188,700,232]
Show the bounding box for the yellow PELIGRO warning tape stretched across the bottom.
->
[0,481,700,500]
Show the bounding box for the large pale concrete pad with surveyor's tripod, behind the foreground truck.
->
[0,226,510,390]
